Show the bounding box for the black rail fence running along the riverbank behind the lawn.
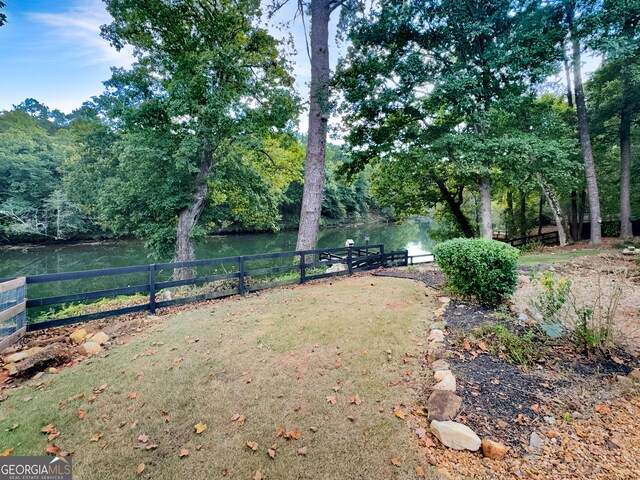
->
[0,244,411,331]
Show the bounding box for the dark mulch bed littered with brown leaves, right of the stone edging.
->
[443,301,640,451]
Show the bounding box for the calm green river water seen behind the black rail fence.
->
[0,220,433,278]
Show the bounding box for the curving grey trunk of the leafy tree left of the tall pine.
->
[173,140,213,280]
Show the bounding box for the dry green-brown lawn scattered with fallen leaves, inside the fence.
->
[0,276,435,480]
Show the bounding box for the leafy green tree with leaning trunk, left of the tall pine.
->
[102,0,297,278]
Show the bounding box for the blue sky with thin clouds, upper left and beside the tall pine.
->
[0,0,338,132]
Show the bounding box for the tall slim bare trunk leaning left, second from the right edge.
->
[571,32,602,245]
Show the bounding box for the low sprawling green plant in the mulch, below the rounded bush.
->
[473,324,540,366]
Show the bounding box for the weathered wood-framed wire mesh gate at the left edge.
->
[0,277,27,352]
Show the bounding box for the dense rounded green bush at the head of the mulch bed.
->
[434,238,519,304]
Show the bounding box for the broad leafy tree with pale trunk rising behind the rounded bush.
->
[338,0,561,238]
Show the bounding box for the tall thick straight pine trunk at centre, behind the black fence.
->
[296,0,331,250]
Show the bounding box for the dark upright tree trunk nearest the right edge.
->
[620,73,633,238]
